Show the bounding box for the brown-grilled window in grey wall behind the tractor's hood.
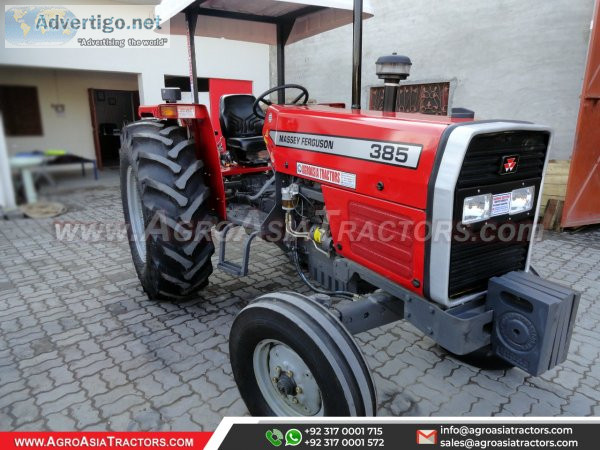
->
[370,82,450,116]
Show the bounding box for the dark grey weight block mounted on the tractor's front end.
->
[486,272,579,376]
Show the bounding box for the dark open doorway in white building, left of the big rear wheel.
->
[89,89,140,169]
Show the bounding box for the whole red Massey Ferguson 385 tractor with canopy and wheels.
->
[121,0,579,416]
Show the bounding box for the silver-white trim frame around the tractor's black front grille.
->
[429,121,552,307]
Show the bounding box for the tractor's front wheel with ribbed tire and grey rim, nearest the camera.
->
[229,292,376,416]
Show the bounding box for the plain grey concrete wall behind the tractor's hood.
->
[282,0,594,159]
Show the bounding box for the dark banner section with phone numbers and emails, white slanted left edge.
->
[206,417,600,450]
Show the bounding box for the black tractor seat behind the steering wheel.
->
[219,94,266,161]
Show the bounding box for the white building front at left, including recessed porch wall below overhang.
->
[0,0,269,157]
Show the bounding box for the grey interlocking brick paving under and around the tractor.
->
[0,188,600,430]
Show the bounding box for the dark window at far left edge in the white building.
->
[0,85,43,136]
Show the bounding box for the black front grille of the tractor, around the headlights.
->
[448,131,549,298]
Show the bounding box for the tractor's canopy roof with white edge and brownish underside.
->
[155,0,373,45]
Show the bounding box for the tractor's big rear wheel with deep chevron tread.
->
[120,119,214,300]
